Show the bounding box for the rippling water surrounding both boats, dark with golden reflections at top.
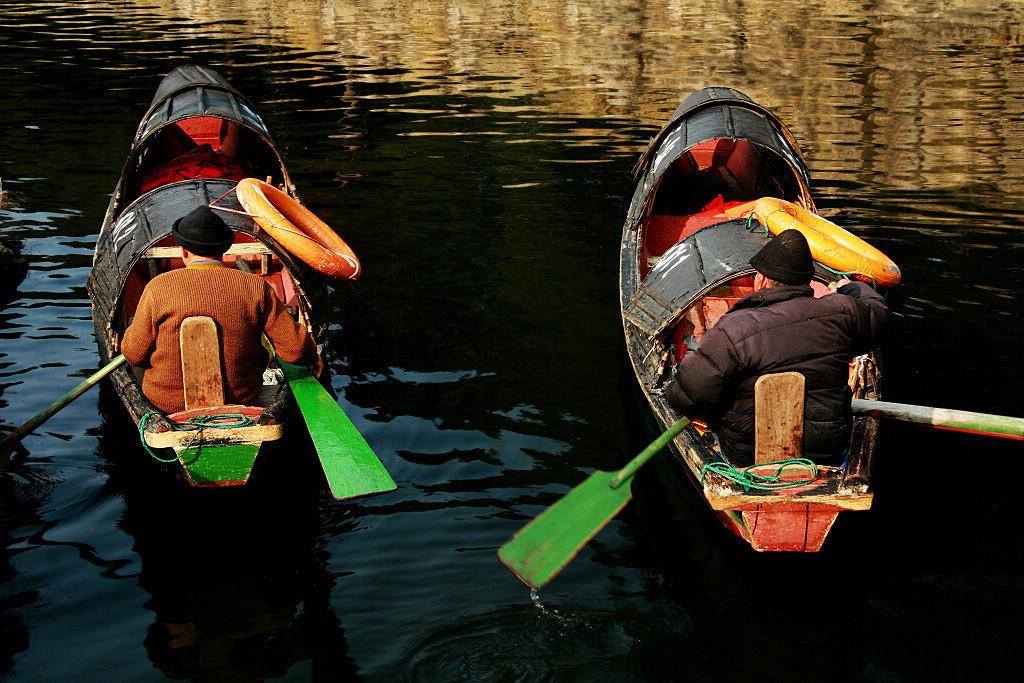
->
[0,0,1024,681]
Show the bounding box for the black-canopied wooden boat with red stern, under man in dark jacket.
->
[620,88,898,552]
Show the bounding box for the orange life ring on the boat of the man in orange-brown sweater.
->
[234,178,359,280]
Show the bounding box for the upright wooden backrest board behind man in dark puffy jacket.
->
[754,373,805,465]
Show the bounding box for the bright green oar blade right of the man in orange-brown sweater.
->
[281,361,398,501]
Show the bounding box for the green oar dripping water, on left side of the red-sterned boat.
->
[498,419,689,588]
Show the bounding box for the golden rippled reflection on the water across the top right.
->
[119,0,1024,194]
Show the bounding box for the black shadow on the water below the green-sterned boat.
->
[93,386,364,680]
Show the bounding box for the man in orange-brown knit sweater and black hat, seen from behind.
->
[121,206,324,413]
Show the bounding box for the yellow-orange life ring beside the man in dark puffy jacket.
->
[750,197,900,287]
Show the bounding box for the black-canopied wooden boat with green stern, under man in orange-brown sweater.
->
[87,66,327,486]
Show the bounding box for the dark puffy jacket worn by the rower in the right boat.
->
[666,282,888,465]
